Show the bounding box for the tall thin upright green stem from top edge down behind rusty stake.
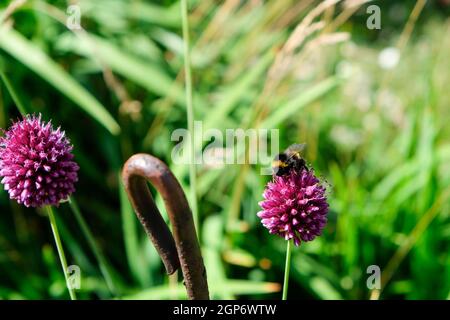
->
[181,0,200,236]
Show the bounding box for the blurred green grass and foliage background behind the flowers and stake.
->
[0,0,450,299]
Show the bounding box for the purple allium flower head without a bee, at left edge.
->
[0,115,79,207]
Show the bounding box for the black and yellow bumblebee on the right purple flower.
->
[272,143,309,176]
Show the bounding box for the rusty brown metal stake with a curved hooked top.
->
[122,153,209,300]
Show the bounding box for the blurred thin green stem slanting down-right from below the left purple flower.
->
[69,197,117,295]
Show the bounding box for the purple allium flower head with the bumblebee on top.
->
[258,170,328,246]
